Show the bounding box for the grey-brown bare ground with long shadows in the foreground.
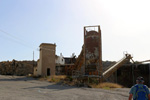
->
[0,75,130,100]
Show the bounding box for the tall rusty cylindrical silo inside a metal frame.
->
[84,26,102,76]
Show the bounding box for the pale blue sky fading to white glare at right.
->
[0,0,150,61]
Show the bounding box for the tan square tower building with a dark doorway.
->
[34,43,56,76]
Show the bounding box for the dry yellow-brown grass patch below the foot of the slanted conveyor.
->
[90,82,123,89]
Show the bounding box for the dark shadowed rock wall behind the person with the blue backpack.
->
[106,64,150,87]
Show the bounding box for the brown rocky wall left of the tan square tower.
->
[0,60,36,76]
